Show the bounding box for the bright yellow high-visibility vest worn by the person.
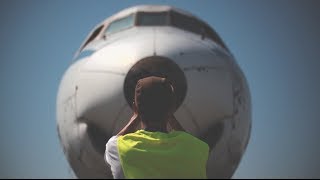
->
[117,130,209,178]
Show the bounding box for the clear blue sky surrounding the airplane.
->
[0,0,320,178]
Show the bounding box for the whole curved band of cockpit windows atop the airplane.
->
[82,10,227,52]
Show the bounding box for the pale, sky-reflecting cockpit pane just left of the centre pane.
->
[105,14,134,35]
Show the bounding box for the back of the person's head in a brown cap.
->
[135,76,175,123]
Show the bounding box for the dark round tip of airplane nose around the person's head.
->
[124,56,187,109]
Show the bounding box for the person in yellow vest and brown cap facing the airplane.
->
[105,76,209,179]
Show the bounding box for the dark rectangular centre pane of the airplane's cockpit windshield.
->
[137,12,169,26]
